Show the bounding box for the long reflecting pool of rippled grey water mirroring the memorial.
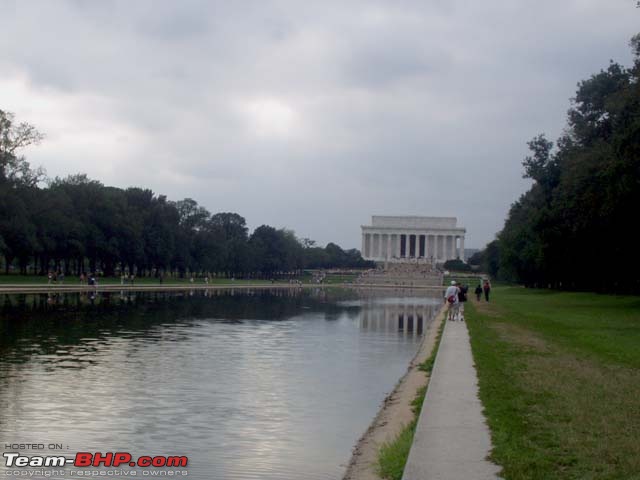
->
[0,290,439,480]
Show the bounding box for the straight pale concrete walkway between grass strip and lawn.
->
[402,321,500,480]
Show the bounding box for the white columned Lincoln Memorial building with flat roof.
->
[362,215,466,262]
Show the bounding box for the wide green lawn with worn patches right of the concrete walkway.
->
[466,287,640,480]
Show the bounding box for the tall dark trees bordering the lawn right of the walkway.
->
[470,34,640,293]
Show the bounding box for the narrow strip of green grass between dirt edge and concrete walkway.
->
[378,321,445,480]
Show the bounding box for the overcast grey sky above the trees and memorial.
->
[0,0,640,248]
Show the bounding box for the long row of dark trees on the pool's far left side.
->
[0,110,371,277]
